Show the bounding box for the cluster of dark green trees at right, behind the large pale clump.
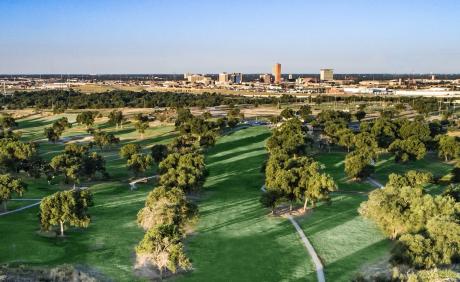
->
[315,110,460,180]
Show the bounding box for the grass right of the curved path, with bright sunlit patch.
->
[298,152,391,281]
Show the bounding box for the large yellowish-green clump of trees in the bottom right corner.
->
[359,171,460,269]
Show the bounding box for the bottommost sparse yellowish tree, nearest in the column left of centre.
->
[136,224,191,278]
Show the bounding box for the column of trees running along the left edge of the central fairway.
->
[135,109,219,278]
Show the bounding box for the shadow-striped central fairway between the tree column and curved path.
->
[175,127,316,281]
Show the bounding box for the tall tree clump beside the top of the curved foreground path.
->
[260,117,337,213]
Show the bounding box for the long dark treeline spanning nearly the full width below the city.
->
[0,90,447,111]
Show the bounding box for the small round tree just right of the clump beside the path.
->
[345,151,374,180]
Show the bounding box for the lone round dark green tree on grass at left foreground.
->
[40,189,93,236]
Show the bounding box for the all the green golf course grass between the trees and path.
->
[0,114,451,281]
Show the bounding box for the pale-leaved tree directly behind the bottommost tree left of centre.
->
[137,186,198,232]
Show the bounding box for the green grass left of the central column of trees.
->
[0,115,175,281]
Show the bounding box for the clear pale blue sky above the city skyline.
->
[0,0,460,73]
